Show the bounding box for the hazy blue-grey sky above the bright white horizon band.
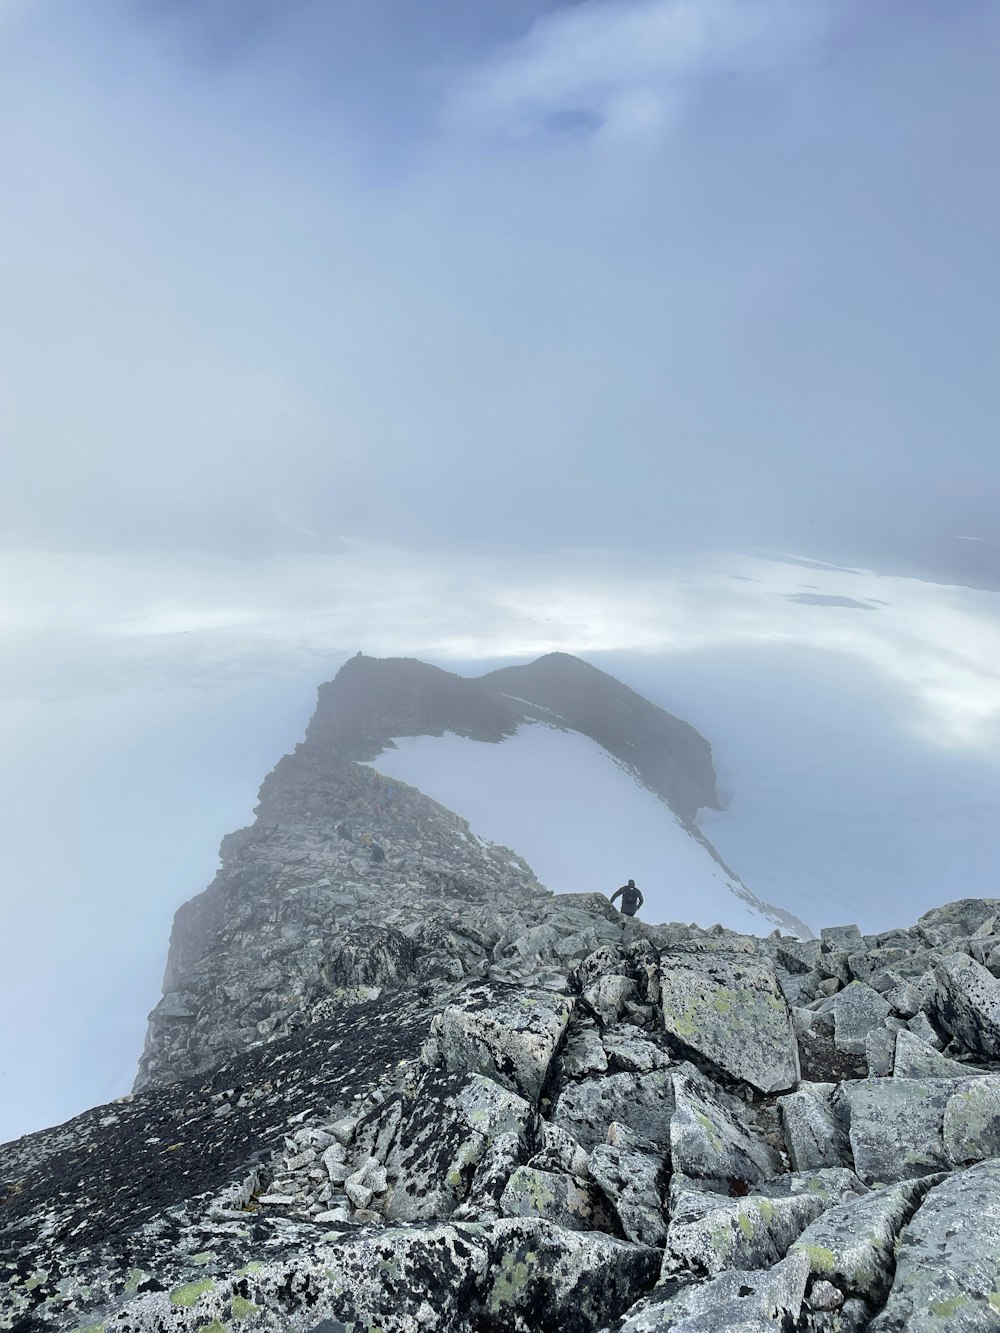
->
[0,0,1000,584]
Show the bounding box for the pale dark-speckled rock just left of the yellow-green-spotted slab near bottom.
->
[663,1190,827,1277]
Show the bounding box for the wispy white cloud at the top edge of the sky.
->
[447,0,831,140]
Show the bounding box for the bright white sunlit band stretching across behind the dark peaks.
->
[0,541,1000,753]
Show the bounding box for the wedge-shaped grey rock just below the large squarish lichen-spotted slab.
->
[669,1072,780,1182]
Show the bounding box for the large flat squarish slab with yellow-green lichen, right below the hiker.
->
[660,952,799,1092]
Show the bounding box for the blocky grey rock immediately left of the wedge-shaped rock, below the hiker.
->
[552,1069,673,1149]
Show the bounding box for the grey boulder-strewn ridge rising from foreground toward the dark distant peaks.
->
[0,663,1000,1333]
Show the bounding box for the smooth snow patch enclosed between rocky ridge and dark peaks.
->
[373,725,773,933]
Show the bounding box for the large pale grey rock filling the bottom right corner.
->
[869,1161,1000,1333]
